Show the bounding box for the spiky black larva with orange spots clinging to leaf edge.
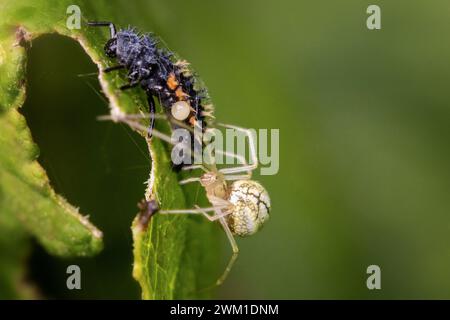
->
[88,22,212,136]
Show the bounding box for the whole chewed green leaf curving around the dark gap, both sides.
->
[0,0,218,299]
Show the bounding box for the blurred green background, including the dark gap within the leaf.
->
[15,0,450,299]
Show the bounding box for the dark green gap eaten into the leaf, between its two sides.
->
[21,35,150,299]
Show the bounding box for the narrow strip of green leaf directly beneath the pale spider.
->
[132,126,219,299]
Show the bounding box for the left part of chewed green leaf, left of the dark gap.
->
[0,1,107,298]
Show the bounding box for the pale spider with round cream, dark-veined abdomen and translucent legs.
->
[102,114,270,285]
